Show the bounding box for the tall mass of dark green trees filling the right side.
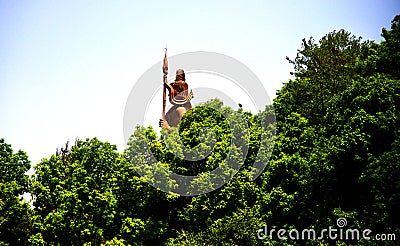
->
[266,17,400,244]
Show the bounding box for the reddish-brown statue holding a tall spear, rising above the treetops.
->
[159,51,193,129]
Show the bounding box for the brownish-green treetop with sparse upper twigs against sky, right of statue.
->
[282,29,362,124]
